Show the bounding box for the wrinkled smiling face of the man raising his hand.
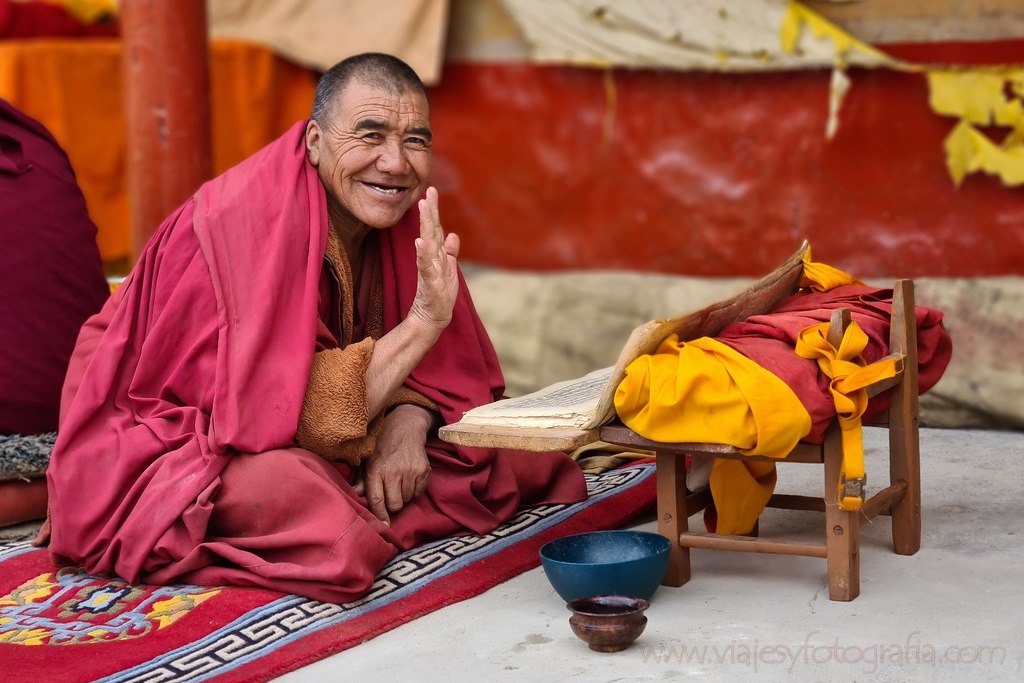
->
[306,80,432,230]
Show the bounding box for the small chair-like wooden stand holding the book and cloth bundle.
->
[440,281,921,600]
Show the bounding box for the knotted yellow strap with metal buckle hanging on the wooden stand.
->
[796,321,896,510]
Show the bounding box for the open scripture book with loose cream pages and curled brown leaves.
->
[441,242,809,438]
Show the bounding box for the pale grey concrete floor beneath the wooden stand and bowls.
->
[276,429,1024,683]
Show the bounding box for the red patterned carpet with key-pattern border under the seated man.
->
[0,461,654,683]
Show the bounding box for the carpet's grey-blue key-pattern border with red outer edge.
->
[0,462,654,683]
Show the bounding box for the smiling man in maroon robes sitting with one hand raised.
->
[41,53,586,603]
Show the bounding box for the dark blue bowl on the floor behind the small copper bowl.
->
[541,529,669,602]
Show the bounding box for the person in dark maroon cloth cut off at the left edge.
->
[0,99,110,435]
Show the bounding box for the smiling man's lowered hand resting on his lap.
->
[356,404,434,523]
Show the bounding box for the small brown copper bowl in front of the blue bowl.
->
[565,595,650,652]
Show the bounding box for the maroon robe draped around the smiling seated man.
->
[48,122,586,602]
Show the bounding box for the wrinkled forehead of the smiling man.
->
[333,81,430,129]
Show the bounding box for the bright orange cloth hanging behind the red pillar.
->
[0,39,316,262]
